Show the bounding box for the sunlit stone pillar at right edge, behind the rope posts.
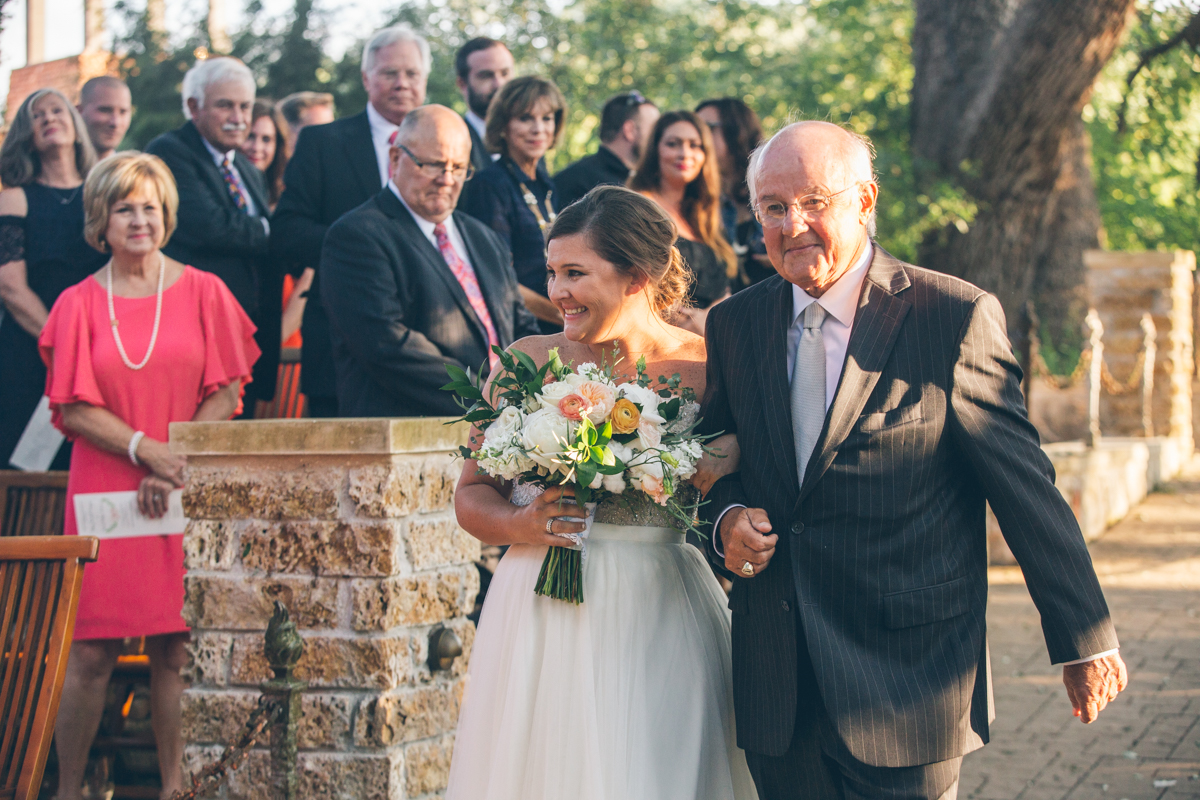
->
[1084,251,1195,455]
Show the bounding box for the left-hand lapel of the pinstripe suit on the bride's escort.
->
[754,278,799,495]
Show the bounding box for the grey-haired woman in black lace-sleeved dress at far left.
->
[0,89,108,469]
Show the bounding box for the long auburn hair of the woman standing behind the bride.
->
[629,112,738,278]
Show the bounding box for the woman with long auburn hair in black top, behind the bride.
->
[629,112,738,335]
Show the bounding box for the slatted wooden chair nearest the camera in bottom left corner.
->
[0,536,100,800]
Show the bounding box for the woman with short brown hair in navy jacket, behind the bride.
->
[458,76,566,333]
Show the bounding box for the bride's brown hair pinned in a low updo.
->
[546,186,691,319]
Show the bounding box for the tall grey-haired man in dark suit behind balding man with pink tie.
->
[271,25,432,417]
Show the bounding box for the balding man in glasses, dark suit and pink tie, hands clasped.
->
[320,106,538,416]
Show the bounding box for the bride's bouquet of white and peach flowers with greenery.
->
[443,348,707,603]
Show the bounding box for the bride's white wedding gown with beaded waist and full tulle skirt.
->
[446,486,757,800]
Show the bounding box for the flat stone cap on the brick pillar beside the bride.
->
[170,416,470,456]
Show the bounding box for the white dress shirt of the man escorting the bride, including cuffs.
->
[713,245,1117,667]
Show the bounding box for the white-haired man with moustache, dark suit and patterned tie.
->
[146,58,283,416]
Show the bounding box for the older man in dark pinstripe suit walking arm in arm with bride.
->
[704,122,1126,800]
